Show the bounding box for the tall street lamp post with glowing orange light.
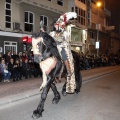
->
[96,2,102,56]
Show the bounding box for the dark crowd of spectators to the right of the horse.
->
[80,53,120,70]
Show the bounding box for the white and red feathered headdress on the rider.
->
[55,12,77,31]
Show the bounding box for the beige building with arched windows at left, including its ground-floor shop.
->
[0,0,68,54]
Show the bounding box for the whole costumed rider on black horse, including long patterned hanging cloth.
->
[50,12,77,93]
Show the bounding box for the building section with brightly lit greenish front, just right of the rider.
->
[68,0,87,53]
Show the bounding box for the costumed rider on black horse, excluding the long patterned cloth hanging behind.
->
[50,12,77,77]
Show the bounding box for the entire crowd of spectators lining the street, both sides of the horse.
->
[0,51,120,82]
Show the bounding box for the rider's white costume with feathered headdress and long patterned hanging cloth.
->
[50,12,77,93]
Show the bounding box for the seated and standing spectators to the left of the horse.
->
[0,51,42,82]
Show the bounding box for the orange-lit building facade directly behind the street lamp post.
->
[87,0,111,54]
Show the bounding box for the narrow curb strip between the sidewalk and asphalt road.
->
[0,69,120,107]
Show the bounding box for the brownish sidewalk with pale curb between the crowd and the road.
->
[0,66,120,107]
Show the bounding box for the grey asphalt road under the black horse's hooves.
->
[0,68,120,120]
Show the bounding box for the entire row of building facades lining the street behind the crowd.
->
[0,0,120,54]
